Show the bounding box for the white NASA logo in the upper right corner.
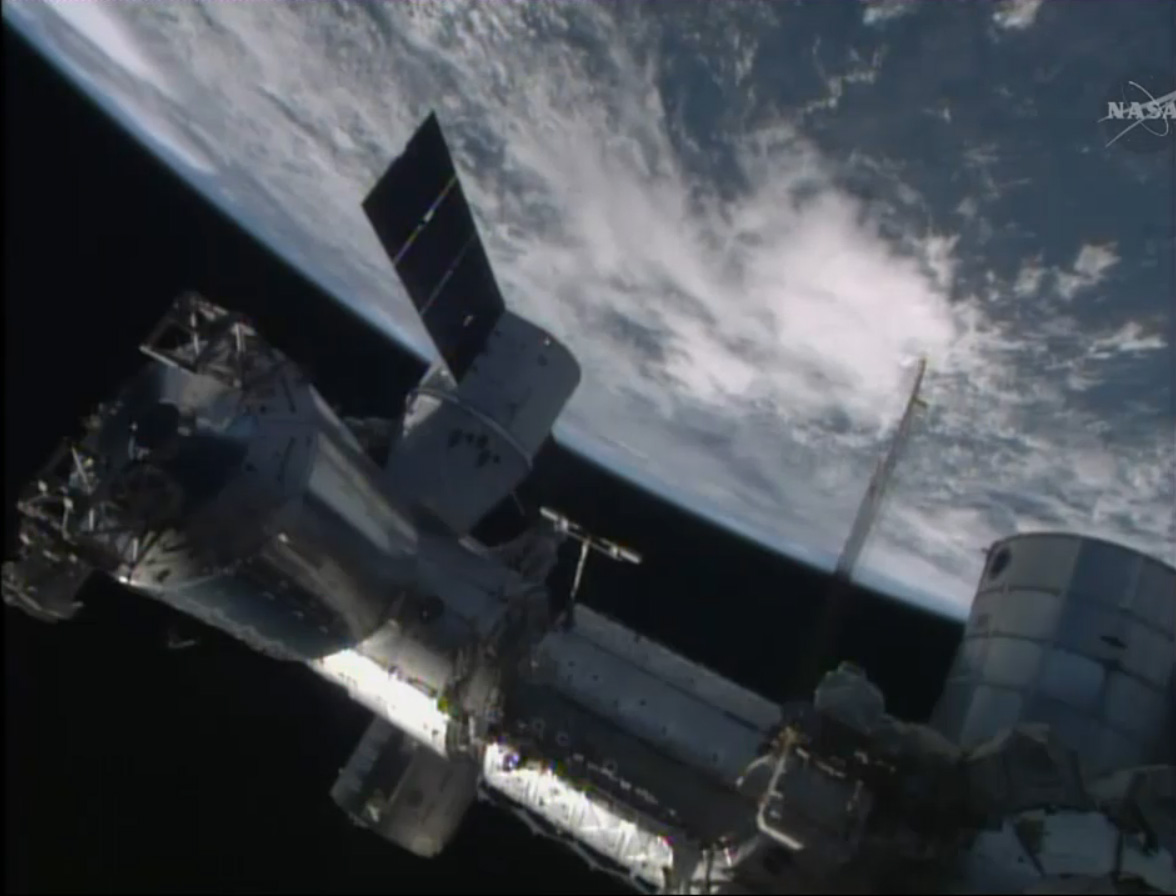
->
[1098,71,1176,153]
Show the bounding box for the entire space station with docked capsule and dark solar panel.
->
[2,115,1176,894]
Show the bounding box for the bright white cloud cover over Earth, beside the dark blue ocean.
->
[8,0,1176,613]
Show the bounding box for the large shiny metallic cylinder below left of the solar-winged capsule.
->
[112,338,415,660]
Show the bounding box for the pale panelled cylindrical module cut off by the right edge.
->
[933,533,1176,771]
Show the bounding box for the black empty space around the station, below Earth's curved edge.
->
[4,28,960,892]
